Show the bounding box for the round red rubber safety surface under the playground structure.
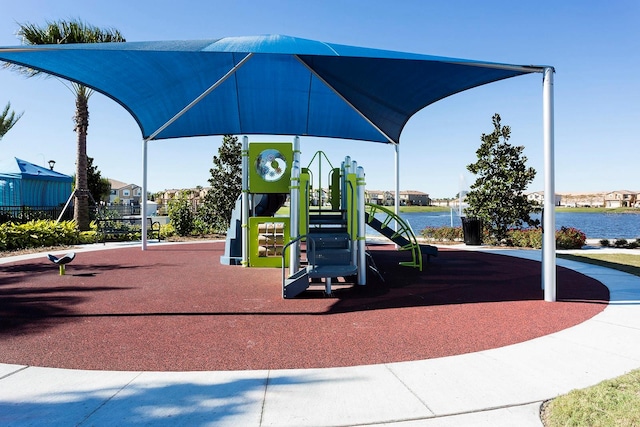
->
[0,242,609,371]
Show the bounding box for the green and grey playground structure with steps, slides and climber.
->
[220,137,437,298]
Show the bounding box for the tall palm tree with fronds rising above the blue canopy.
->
[11,20,126,231]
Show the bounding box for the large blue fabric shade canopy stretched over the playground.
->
[0,35,542,143]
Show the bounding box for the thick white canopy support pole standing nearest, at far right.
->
[542,67,556,302]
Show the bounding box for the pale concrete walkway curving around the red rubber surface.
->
[0,244,640,427]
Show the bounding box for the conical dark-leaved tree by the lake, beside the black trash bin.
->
[465,114,540,242]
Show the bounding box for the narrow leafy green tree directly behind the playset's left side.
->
[198,135,242,232]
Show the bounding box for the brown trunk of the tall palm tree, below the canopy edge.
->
[73,88,90,231]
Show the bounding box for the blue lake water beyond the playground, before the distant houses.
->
[400,212,640,240]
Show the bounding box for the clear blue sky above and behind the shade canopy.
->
[0,0,640,198]
